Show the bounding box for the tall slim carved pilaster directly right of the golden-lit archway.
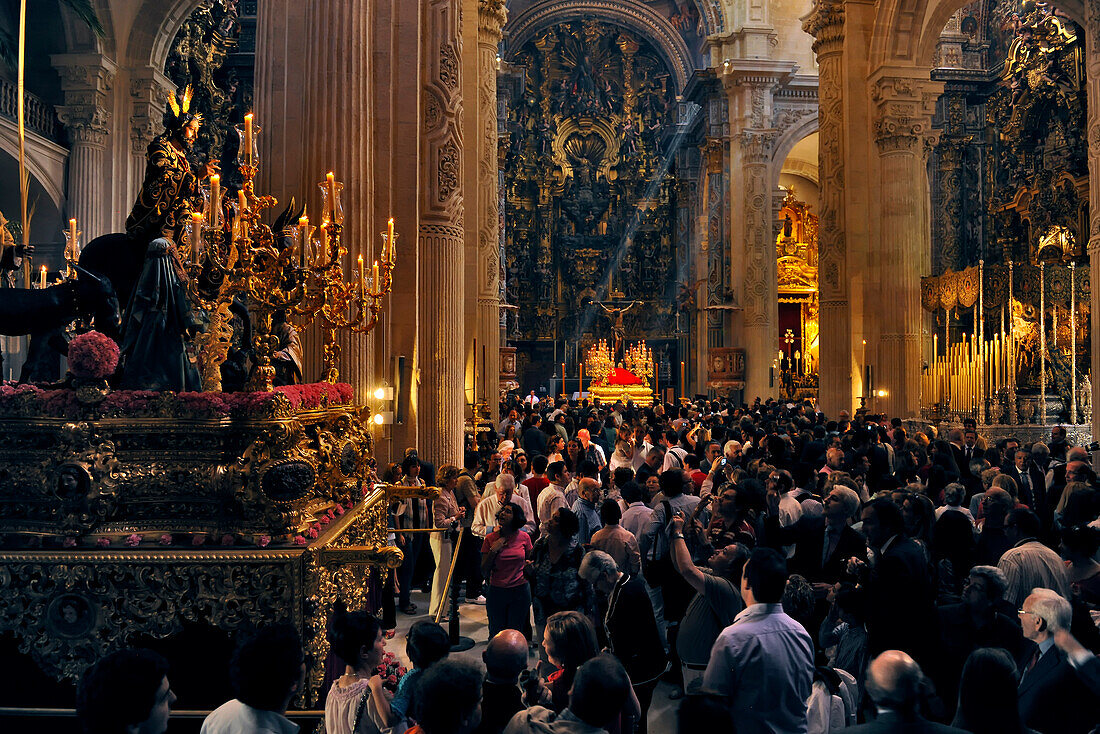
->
[802,0,851,416]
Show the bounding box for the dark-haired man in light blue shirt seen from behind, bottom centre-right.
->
[703,548,814,734]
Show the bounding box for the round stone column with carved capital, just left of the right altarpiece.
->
[871,77,937,418]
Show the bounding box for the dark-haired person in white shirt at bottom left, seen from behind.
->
[200,624,306,734]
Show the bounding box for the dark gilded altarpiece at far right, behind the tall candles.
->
[922,0,1090,423]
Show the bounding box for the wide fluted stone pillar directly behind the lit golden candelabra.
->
[256,0,376,402]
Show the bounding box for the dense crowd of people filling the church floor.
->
[75,396,1100,734]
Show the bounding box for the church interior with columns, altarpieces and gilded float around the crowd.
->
[0,0,1100,730]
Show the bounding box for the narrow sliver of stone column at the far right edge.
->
[1085,2,1100,440]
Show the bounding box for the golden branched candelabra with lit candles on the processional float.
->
[180,113,397,391]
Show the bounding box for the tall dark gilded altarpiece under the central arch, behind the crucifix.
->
[501,20,689,381]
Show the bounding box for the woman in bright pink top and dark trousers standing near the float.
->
[482,502,531,637]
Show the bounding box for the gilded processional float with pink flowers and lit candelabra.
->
[0,114,420,706]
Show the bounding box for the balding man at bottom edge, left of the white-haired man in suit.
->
[844,650,963,734]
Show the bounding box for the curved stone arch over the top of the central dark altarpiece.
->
[505,0,694,94]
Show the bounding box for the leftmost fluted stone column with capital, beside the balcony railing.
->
[50,54,118,242]
